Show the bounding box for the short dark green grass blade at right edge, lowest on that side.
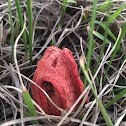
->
[104,88,126,108]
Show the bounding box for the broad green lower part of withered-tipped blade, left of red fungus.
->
[23,90,38,123]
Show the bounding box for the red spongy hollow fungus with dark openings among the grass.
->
[31,47,89,115]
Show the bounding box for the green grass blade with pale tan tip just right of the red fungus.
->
[80,58,113,126]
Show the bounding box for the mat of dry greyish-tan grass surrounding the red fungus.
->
[0,0,126,126]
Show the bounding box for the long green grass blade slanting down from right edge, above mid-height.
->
[103,23,126,83]
